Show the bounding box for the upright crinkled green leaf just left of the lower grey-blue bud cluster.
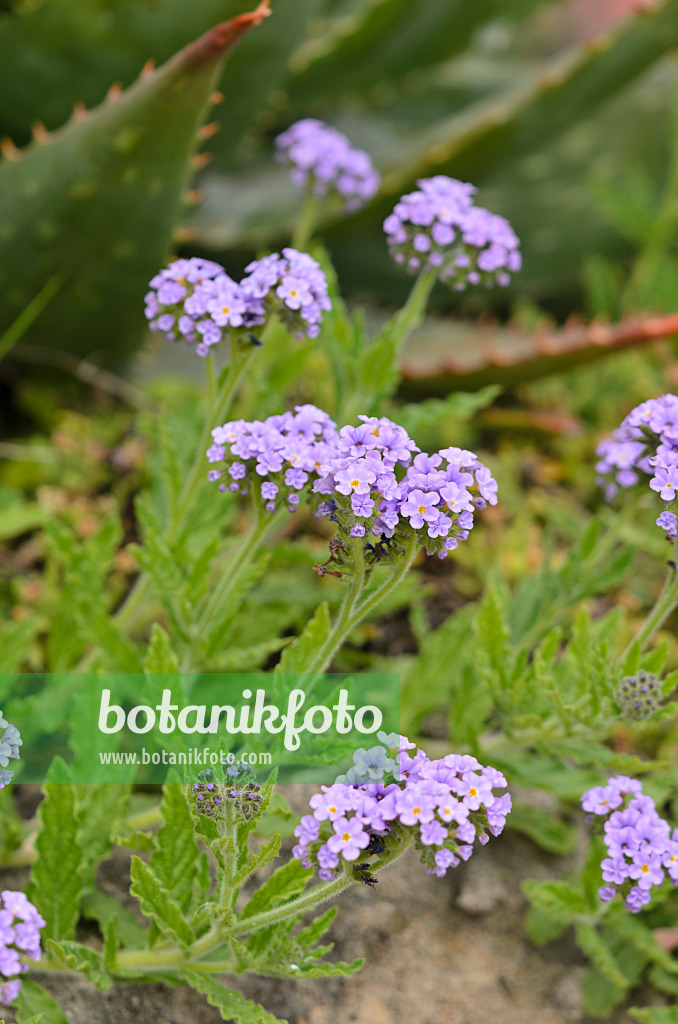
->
[149,784,198,912]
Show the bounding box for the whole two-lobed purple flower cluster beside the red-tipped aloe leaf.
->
[144,249,331,356]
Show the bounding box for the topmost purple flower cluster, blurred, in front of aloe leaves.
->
[276,118,381,211]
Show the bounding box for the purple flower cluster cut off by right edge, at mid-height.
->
[596,394,678,541]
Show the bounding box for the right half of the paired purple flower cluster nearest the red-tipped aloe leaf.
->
[242,249,332,338]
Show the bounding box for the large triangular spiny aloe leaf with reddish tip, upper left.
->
[0,0,268,362]
